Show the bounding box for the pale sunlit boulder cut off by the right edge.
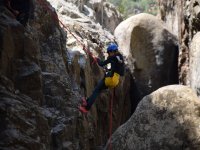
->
[189,32,200,96]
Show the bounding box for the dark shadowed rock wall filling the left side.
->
[0,3,78,149]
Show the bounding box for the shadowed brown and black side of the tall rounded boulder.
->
[130,27,179,113]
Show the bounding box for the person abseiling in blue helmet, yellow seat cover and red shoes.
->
[79,43,124,113]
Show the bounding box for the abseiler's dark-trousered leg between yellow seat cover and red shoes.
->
[86,79,107,110]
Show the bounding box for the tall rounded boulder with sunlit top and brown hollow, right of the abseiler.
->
[115,13,178,110]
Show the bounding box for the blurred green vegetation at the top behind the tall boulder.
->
[108,0,157,18]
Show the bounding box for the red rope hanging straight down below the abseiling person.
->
[109,89,115,150]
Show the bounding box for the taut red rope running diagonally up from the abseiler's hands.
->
[38,0,97,64]
